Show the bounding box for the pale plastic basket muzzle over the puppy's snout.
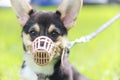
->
[32,36,55,66]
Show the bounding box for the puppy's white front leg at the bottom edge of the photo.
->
[20,66,37,80]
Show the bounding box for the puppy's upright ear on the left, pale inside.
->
[10,0,33,26]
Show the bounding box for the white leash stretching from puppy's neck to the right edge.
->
[68,14,120,49]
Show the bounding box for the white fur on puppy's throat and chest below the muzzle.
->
[24,53,56,75]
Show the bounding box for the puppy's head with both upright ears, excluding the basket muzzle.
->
[11,0,82,65]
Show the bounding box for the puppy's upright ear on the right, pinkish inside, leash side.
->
[58,0,83,30]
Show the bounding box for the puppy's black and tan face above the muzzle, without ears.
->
[22,10,67,51]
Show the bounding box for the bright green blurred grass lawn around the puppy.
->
[0,5,120,80]
